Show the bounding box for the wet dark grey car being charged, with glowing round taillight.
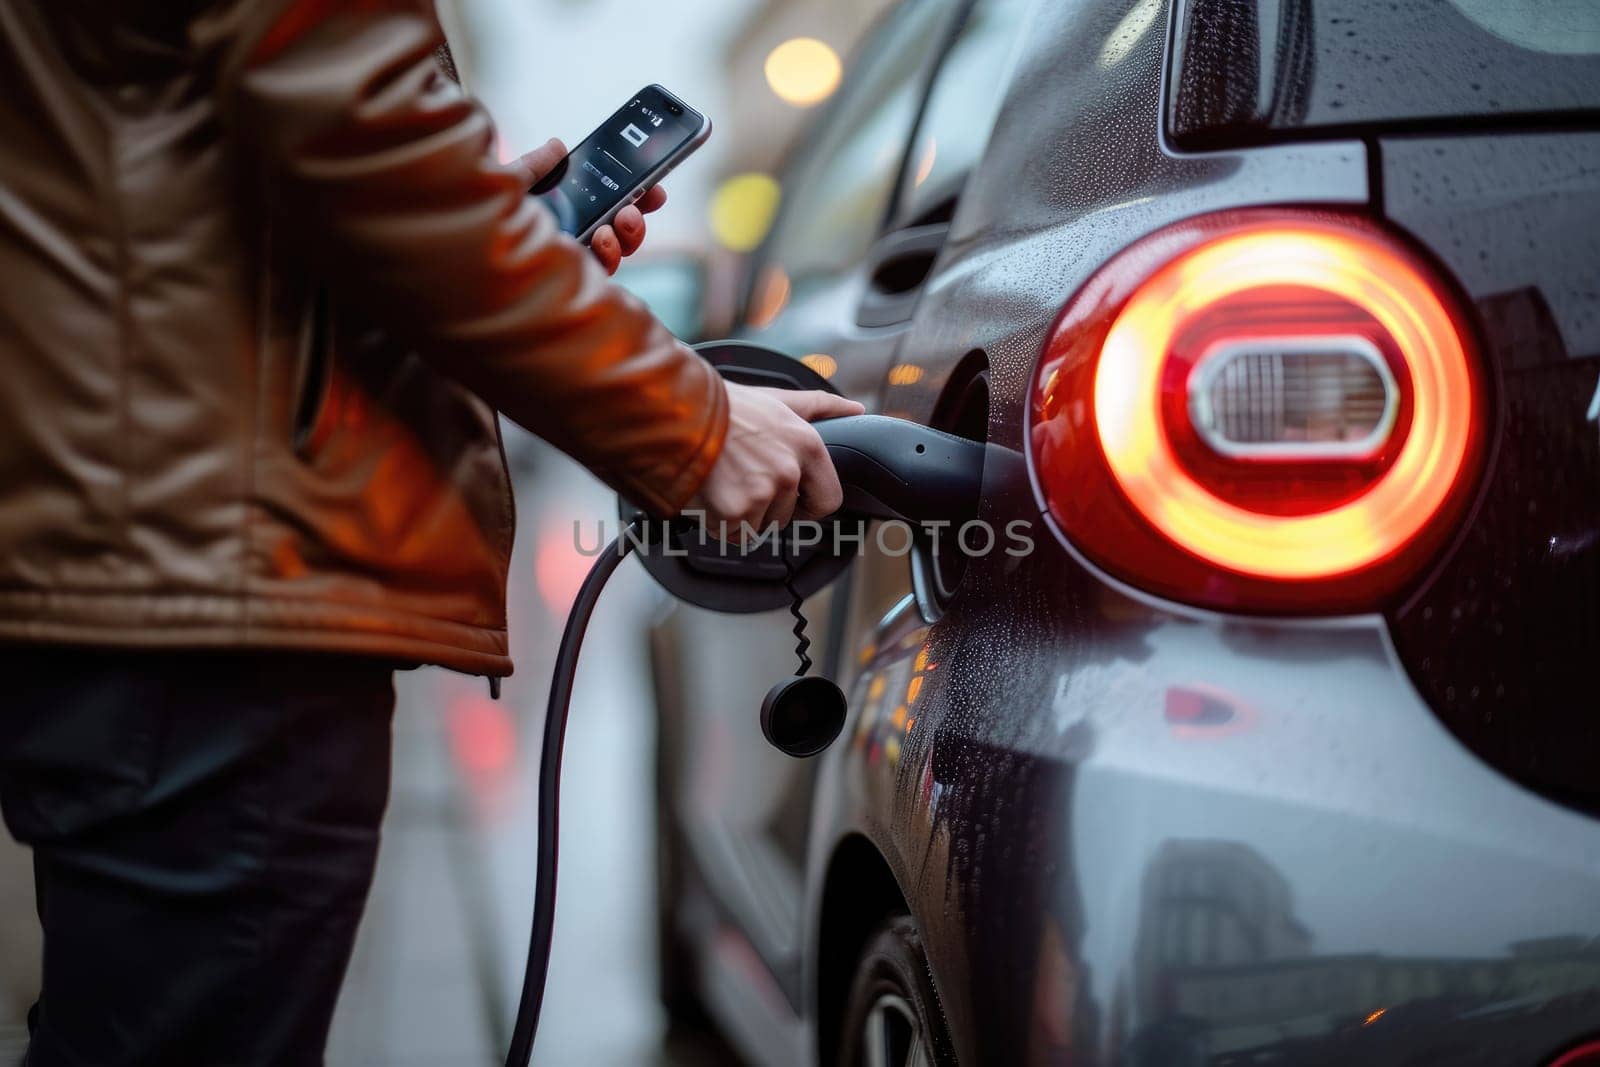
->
[653,0,1600,1067]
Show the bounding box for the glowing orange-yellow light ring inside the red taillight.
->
[1094,224,1475,579]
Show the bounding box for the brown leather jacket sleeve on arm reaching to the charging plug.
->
[195,0,728,515]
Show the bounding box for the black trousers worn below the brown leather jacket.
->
[0,646,394,1067]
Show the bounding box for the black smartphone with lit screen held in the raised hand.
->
[528,85,710,245]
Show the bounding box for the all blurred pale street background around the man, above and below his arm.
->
[0,0,891,1067]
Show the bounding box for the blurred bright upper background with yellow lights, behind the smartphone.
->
[440,0,898,334]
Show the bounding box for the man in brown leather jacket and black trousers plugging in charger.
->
[0,0,859,1067]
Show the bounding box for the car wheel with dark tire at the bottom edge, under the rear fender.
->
[834,915,955,1067]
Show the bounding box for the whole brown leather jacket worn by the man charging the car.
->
[0,0,728,675]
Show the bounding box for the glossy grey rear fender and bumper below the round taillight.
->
[813,543,1600,1064]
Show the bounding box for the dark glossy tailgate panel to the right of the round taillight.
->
[1379,131,1600,811]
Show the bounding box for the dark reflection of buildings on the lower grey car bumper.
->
[1128,838,1600,1064]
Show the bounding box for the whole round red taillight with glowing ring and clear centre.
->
[1030,211,1483,613]
